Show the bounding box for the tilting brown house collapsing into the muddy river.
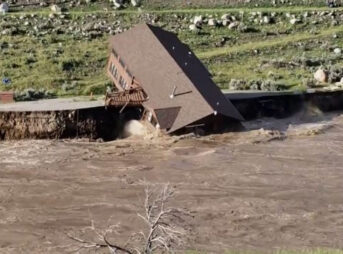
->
[106,24,243,133]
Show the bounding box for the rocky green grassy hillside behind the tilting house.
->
[0,0,343,98]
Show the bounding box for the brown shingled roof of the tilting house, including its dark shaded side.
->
[110,24,243,132]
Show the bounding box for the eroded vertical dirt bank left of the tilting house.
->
[0,108,119,140]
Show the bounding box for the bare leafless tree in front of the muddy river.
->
[67,182,190,254]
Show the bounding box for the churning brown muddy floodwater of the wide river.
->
[0,112,343,253]
